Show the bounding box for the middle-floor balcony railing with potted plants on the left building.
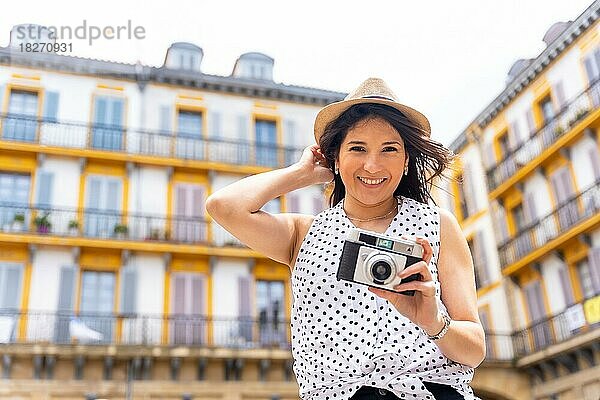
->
[0,202,223,244]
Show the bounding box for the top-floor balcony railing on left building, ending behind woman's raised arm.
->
[0,114,303,168]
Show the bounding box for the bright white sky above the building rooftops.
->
[0,0,592,145]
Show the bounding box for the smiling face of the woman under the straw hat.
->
[338,118,407,204]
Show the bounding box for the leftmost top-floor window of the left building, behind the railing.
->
[2,90,38,142]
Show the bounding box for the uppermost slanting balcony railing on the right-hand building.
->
[487,80,600,190]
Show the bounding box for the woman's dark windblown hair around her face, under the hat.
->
[319,103,454,207]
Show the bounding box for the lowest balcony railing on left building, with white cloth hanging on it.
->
[0,309,291,349]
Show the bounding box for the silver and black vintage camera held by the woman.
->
[336,228,423,296]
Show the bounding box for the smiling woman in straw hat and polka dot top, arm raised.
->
[206,78,485,400]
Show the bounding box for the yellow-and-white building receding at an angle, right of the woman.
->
[437,2,600,400]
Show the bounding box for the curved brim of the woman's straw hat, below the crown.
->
[314,98,431,143]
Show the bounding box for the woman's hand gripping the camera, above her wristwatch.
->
[369,238,440,334]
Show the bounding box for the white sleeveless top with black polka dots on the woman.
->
[291,198,477,400]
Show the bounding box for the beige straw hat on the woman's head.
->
[315,78,431,143]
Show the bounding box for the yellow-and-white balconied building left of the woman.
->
[0,28,344,399]
